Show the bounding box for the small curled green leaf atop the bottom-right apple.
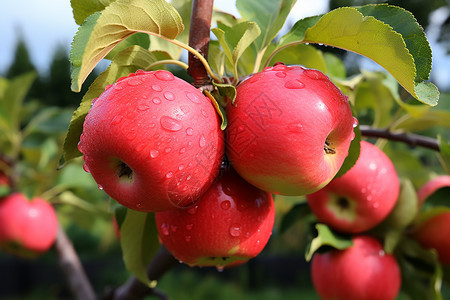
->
[305,223,353,261]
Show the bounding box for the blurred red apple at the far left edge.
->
[0,193,58,258]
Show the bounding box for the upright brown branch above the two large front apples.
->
[188,0,214,87]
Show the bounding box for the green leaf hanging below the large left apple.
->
[120,209,159,287]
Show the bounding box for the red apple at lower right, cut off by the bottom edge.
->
[311,235,401,300]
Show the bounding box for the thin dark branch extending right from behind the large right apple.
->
[359,125,439,151]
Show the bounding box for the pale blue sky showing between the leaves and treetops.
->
[0,0,450,87]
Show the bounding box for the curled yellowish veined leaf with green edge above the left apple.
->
[69,0,184,92]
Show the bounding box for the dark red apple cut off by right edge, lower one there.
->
[412,211,450,266]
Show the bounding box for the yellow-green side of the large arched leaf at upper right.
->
[277,6,439,105]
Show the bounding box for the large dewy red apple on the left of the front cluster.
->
[78,70,224,212]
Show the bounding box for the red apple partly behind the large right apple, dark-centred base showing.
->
[306,141,400,233]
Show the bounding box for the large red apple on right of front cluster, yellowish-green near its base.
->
[226,64,356,195]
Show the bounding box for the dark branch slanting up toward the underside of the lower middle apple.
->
[104,246,178,300]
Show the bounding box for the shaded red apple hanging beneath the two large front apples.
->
[155,169,275,268]
